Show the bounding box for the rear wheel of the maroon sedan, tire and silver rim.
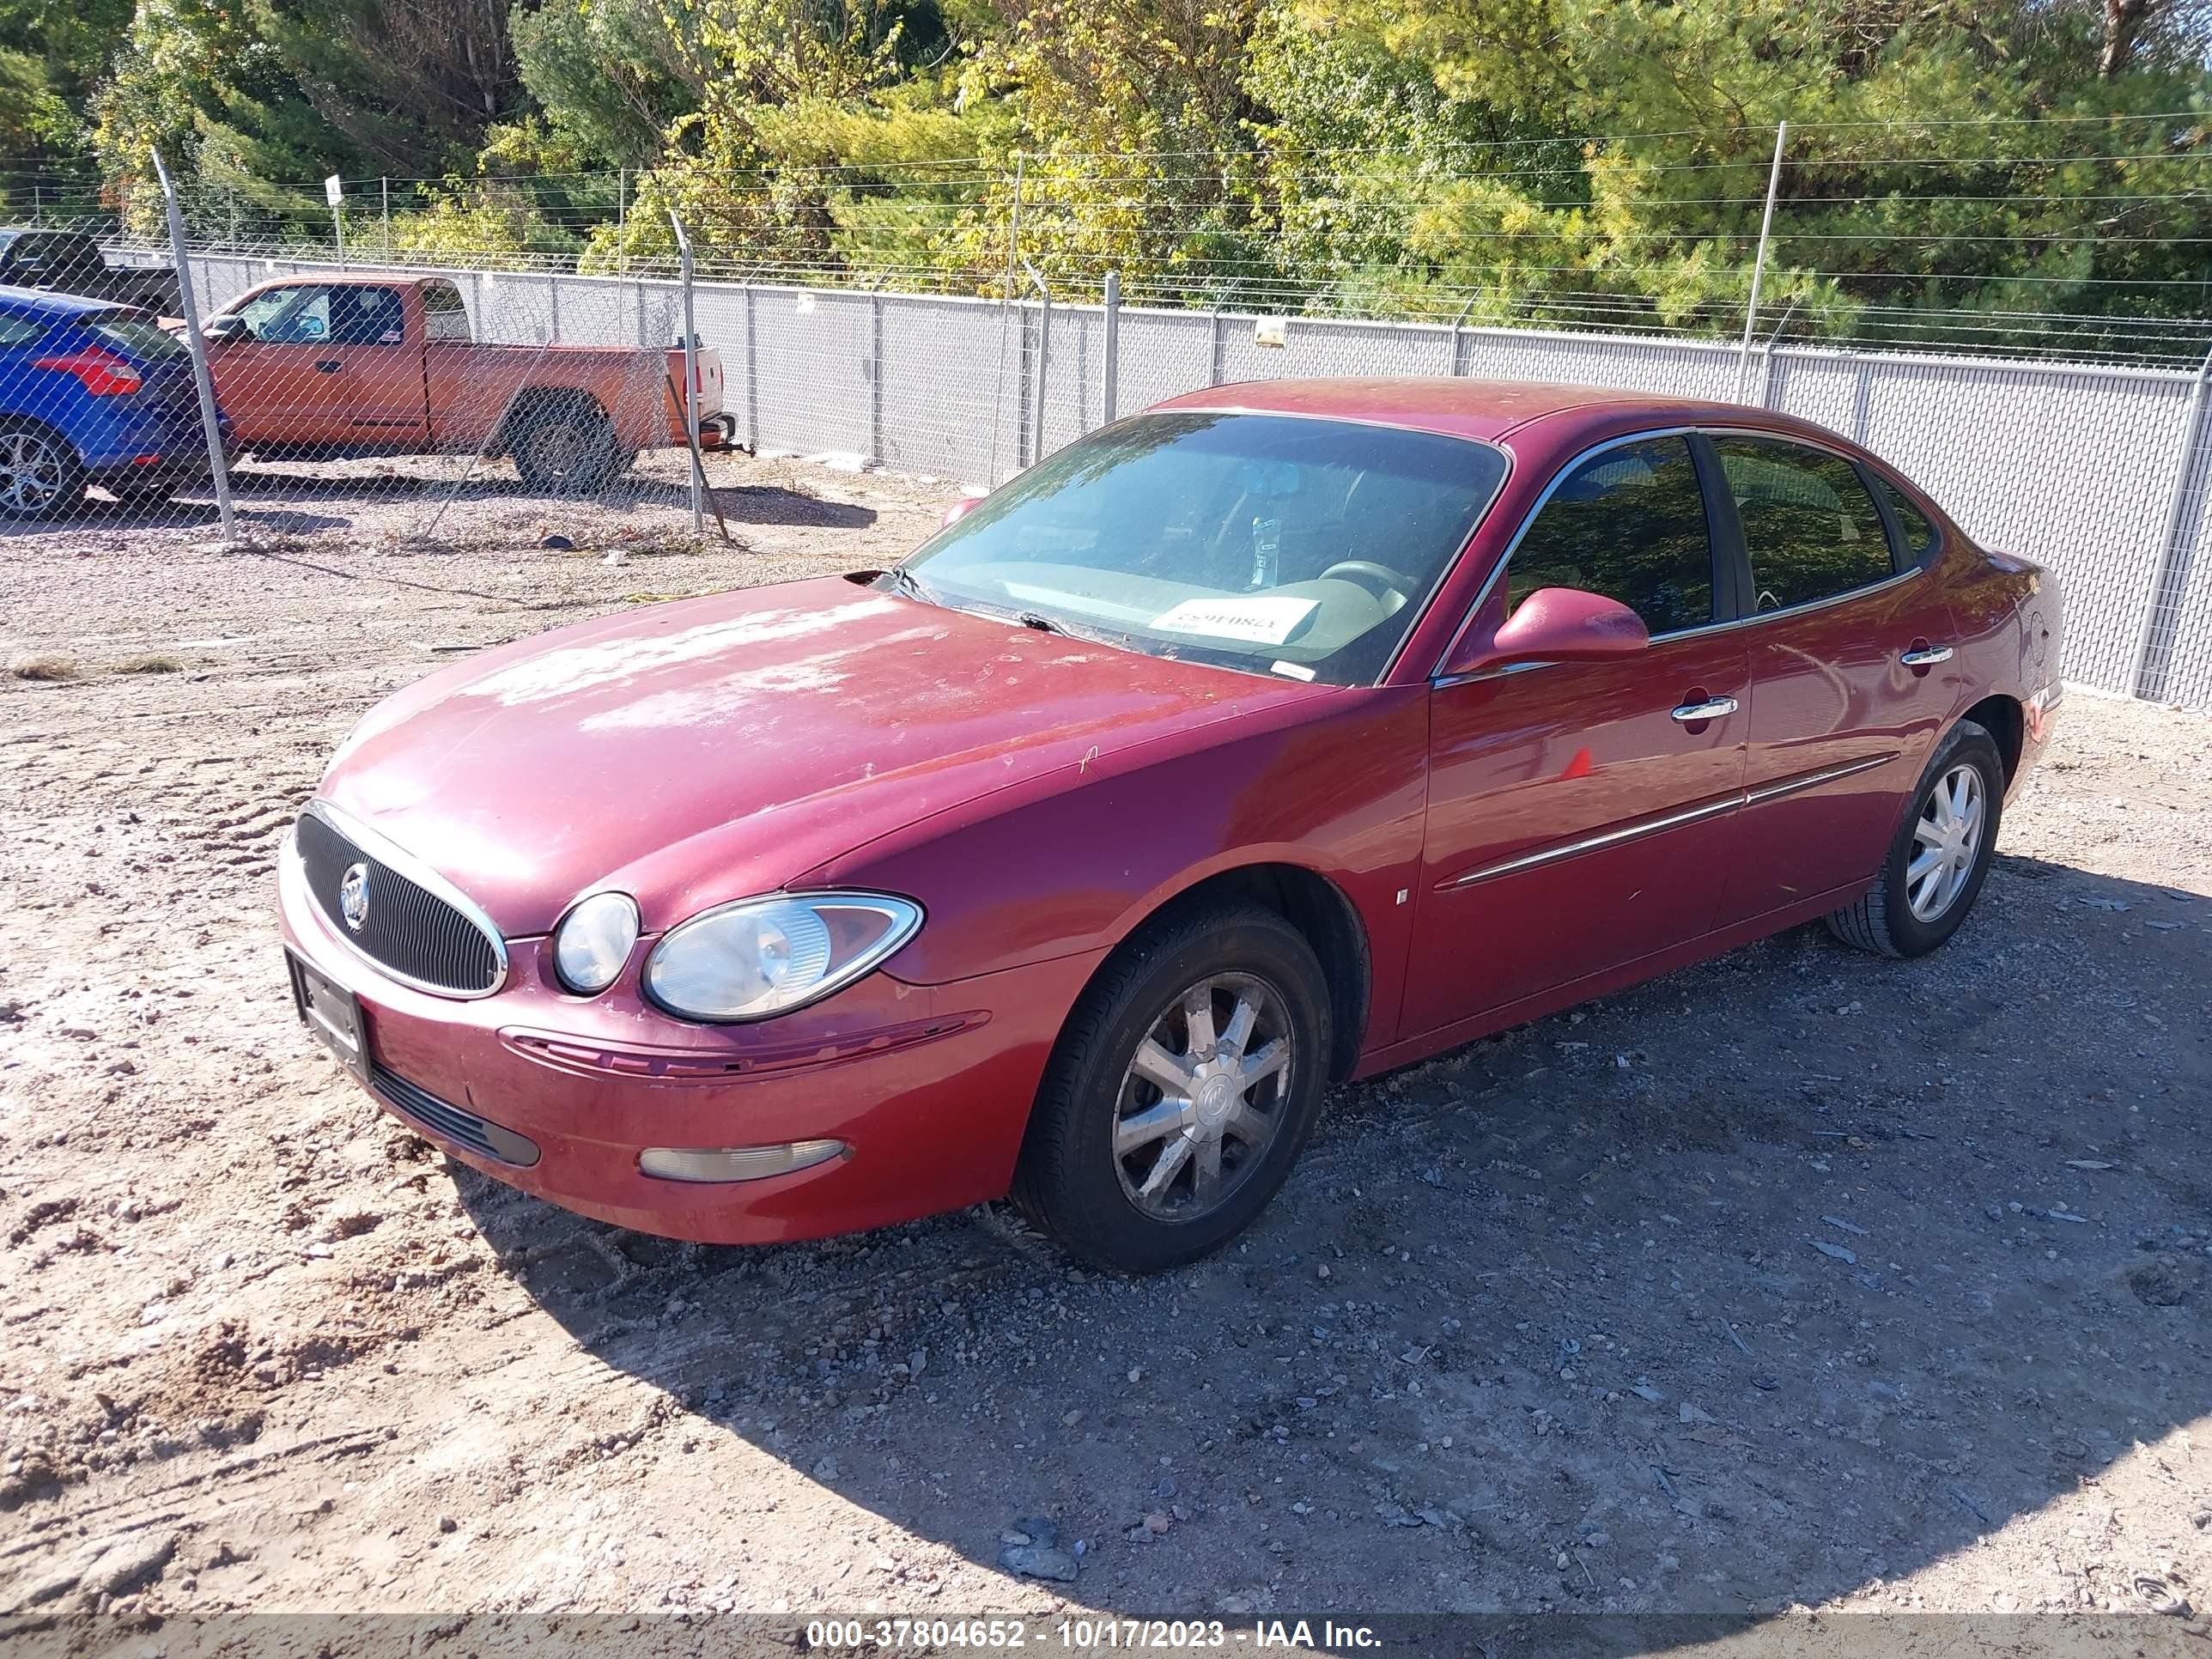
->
[1827,721,2004,956]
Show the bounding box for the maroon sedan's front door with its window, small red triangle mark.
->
[1401,434,1750,1037]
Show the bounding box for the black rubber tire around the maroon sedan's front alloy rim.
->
[1013,905,1332,1274]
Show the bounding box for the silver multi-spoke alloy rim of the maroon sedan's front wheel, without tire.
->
[1113,973,1297,1221]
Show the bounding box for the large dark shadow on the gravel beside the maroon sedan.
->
[458,858,2212,1627]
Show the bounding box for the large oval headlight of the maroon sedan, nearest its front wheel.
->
[646,894,922,1022]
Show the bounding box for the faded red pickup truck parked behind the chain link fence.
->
[204,276,730,493]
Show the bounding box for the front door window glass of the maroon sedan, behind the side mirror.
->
[1506,438,1712,635]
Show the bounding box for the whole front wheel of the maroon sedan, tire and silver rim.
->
[1013,905,1329,1272]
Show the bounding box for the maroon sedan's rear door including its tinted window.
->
[1710,431,1954,921]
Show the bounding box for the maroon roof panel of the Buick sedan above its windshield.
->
[1152,376,1794,442]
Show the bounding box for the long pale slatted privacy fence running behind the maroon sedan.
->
[192,254,2212,706]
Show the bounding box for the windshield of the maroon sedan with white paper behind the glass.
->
[900,411,1506,686]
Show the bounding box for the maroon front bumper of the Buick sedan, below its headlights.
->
[279,845,1097,1243]
